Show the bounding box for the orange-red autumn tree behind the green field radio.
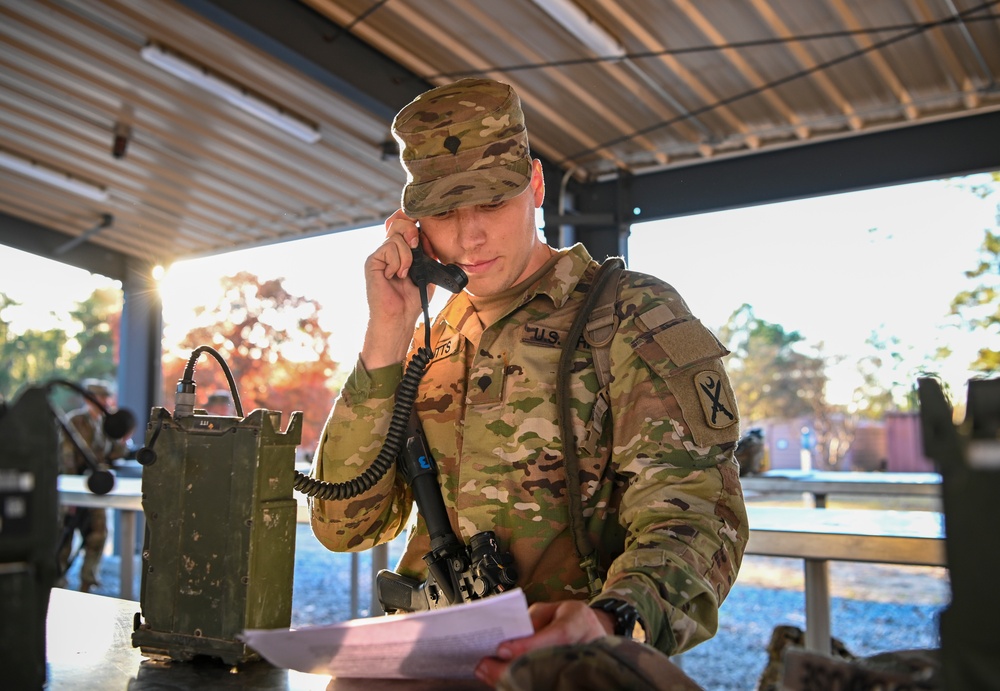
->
[163,272,337,451]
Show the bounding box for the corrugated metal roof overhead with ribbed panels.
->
[0,0,1000,262]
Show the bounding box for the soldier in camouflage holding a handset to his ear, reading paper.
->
[311,79,748,684]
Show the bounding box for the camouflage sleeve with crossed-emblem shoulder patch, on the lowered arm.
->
[602,276,749,654]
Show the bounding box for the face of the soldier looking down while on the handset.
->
[420,160,550,296]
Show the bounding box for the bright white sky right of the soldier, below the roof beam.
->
[629,174,1000,400]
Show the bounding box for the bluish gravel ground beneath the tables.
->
[69,525,949,691]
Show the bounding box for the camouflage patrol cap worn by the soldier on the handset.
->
[392,79,531,218]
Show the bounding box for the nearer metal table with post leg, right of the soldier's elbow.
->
[746,506,947,653]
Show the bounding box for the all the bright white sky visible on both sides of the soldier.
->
[0,175,1000,408]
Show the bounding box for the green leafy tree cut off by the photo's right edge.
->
[951,172,1000,373]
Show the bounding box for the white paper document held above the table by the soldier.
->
[243,588,533,679]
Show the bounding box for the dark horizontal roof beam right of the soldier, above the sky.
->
[570,111,1000,227]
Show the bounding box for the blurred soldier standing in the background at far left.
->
[57,379,127,592]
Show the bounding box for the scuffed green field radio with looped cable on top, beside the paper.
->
[132,346,302,665]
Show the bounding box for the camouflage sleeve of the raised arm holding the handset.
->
[309,360,412,552]
